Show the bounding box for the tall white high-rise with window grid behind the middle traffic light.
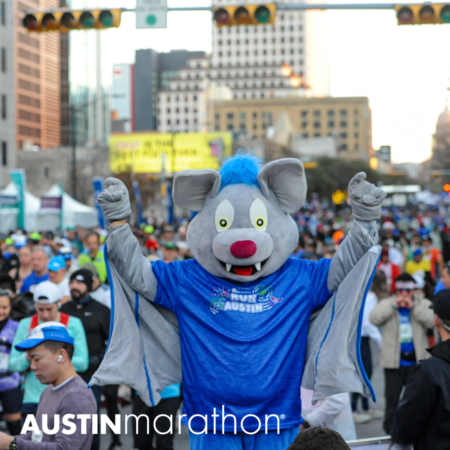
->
[211,0,329,99]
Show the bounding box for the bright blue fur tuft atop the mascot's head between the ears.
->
[219,149,262,189]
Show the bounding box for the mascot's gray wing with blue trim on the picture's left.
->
[89,225,181,406]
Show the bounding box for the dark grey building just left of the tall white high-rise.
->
[134,49,206,131]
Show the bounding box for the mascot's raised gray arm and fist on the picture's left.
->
[98,178,157,300]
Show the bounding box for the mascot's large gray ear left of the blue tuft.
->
[173,169,220,212]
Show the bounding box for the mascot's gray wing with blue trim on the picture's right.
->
[302,246,381,401]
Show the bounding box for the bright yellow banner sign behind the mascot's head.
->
[109,132,233,173]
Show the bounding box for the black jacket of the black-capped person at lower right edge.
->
[391,340,450,450]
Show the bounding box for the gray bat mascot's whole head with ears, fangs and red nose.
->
[173,153,307,282]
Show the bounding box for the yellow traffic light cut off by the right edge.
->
[395,3,450,25]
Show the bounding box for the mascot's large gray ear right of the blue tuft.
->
[258,158,308,214]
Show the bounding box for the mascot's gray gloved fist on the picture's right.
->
[348,172,386,222]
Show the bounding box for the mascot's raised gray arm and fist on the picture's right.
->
[327,172,386,292]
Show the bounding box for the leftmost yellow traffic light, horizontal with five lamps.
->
[23,9,122,33]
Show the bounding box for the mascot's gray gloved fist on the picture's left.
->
[97,178,131,223]
